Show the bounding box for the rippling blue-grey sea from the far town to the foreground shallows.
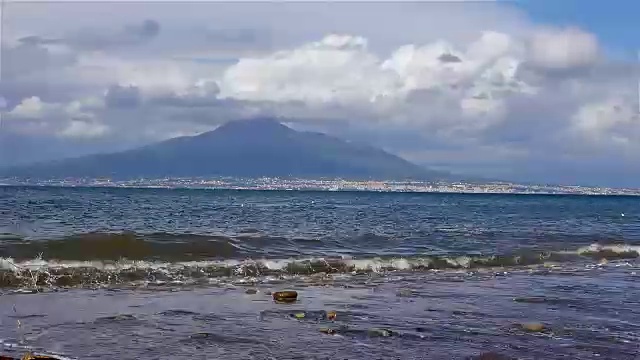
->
[0,186,640,360]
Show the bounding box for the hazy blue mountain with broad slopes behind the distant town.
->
[0,118,446,180]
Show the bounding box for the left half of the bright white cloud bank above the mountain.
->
[220,34,396,105]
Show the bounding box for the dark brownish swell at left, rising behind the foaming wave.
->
[0,229,314,261]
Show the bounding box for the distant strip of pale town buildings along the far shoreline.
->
[0,178,640,196]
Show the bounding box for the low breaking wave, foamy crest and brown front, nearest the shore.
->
[0,244,640,288]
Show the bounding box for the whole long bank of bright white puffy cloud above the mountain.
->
[220,32,536,127]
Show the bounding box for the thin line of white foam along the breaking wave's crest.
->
[0,244,640,276]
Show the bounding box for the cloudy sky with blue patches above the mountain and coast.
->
[0,0,640,187]
